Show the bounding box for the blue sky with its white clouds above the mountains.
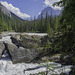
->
[0,0,59,19]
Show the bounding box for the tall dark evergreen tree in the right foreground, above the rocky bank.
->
[52,0,75,53]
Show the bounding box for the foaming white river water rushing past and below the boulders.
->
[0,36,71,75]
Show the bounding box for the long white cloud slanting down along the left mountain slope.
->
[0,1,30,19]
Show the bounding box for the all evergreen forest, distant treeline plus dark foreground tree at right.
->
[0,0,75,75]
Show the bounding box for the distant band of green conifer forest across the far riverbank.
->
[0,6,60,33]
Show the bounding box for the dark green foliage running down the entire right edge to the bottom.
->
[53,0,75,75]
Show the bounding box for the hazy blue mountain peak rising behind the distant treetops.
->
[37,7,62,19]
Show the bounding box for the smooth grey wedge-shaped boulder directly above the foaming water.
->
[6,43,40,63]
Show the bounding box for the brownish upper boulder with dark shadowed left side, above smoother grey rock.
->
[11,34,43,48]
